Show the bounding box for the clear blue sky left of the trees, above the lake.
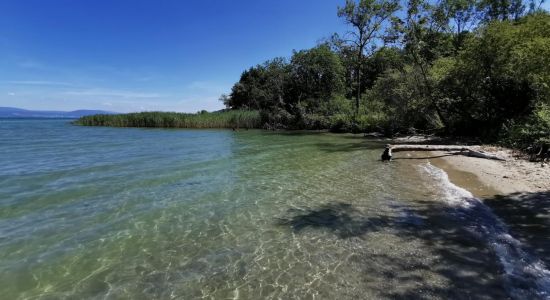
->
[0,0,346,112]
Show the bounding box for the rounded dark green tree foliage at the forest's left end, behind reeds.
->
[229,45,350,113]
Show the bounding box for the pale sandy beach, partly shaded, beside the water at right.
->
[396,146,550,266]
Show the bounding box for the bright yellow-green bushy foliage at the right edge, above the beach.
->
[435,11,550,139]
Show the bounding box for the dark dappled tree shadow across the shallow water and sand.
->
[277,192,550,299]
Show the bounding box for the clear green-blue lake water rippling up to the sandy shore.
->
[0,120,550,299]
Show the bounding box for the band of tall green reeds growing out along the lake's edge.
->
[74,110,261,128]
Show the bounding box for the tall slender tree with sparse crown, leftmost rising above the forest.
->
[338,0,399,114]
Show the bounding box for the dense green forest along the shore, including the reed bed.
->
[77,0,550,148]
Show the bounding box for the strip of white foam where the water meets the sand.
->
[421,163,550,299]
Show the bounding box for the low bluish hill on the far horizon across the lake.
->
[0,107,116,119]
